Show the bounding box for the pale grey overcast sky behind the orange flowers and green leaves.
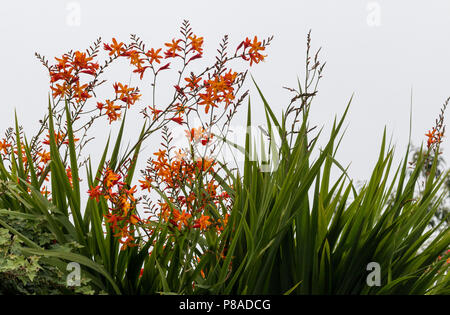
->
[0,0,450,189]
